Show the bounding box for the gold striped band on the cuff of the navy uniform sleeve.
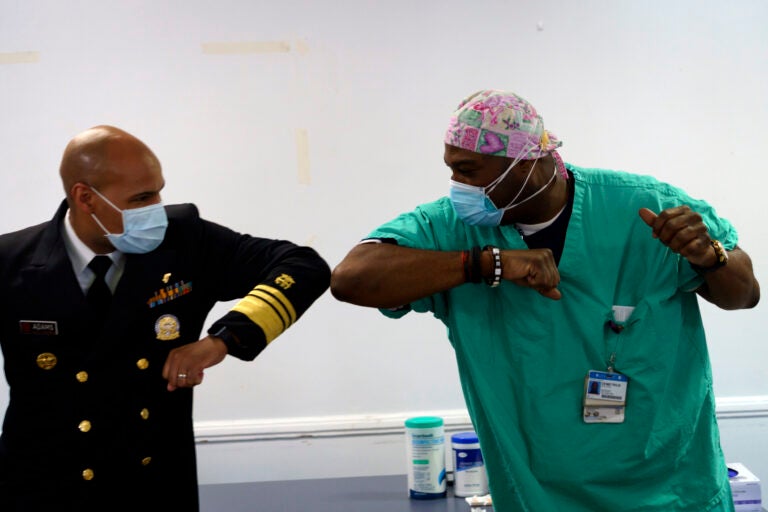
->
[232,284,296,343]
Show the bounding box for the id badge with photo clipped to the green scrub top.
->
[584,370,629,423]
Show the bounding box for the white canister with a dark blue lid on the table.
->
[451,432,488,497]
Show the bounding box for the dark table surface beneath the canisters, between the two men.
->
[200,475,493,512]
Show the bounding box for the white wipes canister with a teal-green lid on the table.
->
[405,416,446,499]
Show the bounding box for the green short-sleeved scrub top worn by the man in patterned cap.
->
[369,165,737,512]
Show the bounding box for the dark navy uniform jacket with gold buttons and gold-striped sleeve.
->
[0,199,330,512]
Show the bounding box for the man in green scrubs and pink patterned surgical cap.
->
[331,90,760,512]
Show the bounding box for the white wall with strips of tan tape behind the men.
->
[0,0,768,492]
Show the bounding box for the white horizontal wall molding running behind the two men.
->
[195,395,768,443]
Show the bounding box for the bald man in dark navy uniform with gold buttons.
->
[0,126,330,512]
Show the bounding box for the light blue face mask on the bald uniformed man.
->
[91,187,168,254]
